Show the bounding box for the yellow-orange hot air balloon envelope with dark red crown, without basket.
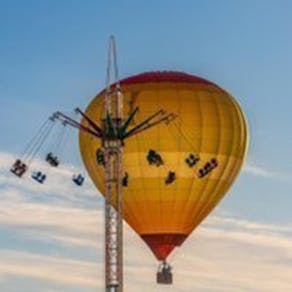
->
[79,71,248,280]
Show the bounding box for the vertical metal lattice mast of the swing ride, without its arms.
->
[103,36,123,292]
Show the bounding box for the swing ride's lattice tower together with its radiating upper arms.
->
[54,36,176,292]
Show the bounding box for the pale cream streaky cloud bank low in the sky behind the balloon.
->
[0,154,292,292]
